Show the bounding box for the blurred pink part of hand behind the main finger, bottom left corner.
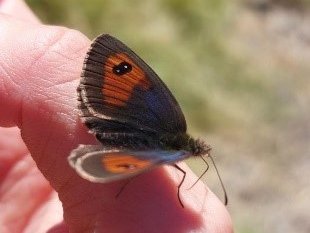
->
[0,127,62,232]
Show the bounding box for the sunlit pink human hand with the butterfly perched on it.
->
[0,0,233,233]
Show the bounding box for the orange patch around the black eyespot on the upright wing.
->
[102,53,150,106]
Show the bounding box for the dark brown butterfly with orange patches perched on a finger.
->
[68,34,211,206]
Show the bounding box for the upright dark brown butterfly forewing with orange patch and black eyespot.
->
[78,35,186,133]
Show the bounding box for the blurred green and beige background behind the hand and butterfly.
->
[27,0,310,233]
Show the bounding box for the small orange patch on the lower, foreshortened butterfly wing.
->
[102,153,151,173]
